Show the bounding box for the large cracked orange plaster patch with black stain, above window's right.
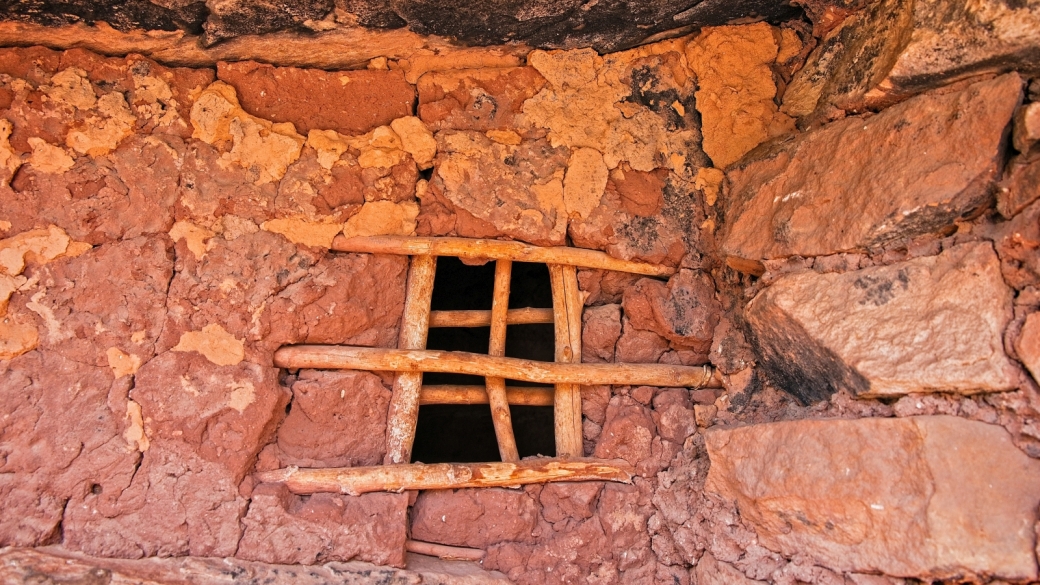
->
[523,40,700,174]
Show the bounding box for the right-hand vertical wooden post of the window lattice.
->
[549,264,584,457]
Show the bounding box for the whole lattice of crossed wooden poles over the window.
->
[257,236,719,494]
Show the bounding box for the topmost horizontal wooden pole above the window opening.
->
[332,235,675,276]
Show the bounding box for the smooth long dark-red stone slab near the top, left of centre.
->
[216,61,415,135]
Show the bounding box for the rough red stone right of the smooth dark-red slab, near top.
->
[416,67,545,132]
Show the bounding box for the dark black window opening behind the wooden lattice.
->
[412,256,555,463]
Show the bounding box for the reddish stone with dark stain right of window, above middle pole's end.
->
[624,270,722,355]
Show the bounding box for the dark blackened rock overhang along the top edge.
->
[0,0,801,52]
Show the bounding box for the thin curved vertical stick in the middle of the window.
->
[485,260,520,461]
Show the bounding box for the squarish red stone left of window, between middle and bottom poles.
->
[277,370,390,467]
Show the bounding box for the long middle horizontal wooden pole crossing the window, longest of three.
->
[275,346,714,388]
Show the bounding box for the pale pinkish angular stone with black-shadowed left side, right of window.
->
[747,244,1018,402]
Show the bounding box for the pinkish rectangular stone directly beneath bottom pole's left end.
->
[235,484,408,567]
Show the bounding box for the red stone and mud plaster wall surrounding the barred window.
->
[0,3,1040,585]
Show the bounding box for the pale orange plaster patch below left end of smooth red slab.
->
[191,81,306,185]
